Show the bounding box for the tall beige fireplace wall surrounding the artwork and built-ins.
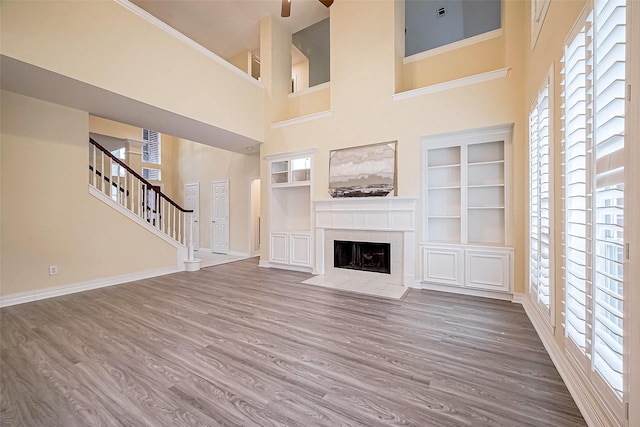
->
[261,1,527,292]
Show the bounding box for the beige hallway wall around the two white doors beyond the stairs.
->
[177,139,260,254]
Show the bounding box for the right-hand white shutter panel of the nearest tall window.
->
[587,0,626,397]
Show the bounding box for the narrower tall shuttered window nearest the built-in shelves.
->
[529,72,553,324]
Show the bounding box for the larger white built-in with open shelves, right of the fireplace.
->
[420,125,513,295]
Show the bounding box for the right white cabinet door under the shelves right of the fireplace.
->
[465,250,511,291]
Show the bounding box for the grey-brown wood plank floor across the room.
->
[0,259,585,427]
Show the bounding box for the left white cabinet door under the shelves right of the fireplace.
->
[422,248,464,286]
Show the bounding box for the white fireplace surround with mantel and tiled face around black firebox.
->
[313,197,417,287]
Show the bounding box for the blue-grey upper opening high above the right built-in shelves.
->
[404,0,501,56]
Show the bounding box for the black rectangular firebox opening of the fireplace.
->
[333,240,391,274]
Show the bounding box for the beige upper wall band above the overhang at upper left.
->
[0,0,264,141]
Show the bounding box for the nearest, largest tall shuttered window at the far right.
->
[562,0,626,404]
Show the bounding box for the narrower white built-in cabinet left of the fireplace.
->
[265,150,315,271]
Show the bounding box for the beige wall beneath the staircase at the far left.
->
[0,92,178,296]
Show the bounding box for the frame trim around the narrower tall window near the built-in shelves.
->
[527,64,556,330]
